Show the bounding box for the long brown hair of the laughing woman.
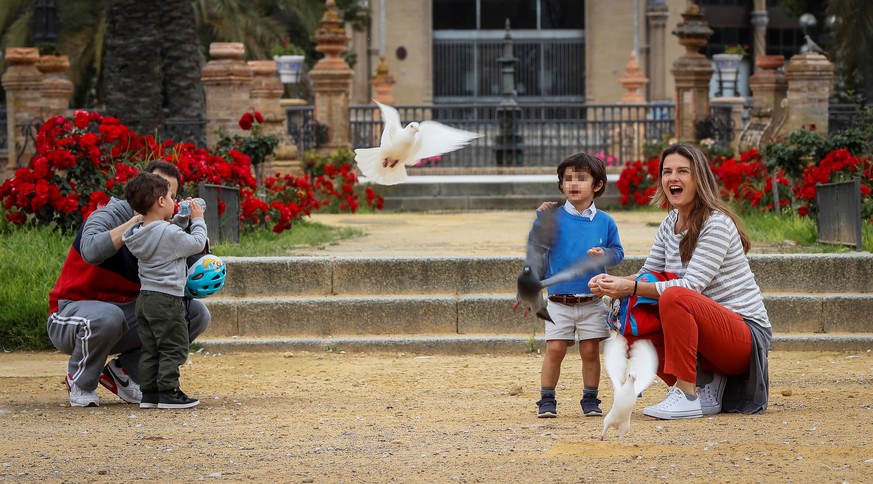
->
[650,143,751,264]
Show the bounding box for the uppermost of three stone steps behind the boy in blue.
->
[221,253,873,301]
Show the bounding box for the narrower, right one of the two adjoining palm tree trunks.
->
[159,0,206,145]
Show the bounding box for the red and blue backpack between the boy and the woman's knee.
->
[606,272,678,336]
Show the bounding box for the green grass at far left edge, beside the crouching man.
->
[0,228,73,350]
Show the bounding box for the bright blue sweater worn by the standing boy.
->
[534,206,624,294]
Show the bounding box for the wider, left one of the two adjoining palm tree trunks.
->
[103,0,163,135]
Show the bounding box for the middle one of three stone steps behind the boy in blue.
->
[199,293,873,338]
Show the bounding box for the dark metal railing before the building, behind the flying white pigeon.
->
[350,104,674,167]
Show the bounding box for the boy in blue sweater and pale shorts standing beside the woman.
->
[534,152,624,418]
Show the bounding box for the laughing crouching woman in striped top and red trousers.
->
[589,144,772,419]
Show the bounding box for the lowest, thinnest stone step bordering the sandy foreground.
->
[196,333,873,355]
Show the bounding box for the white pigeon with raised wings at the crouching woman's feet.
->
[600,333,658,442]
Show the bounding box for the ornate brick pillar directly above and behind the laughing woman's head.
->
[670,3,712,144]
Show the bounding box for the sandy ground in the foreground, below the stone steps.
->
[0,351,873,482]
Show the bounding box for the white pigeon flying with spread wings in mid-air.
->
[355,101,482,185]
